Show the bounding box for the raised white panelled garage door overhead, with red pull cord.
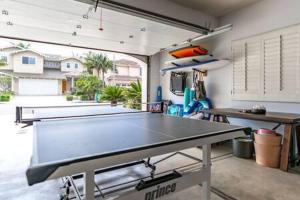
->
[0,0,199,55]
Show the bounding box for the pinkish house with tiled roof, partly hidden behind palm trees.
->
[106,59,142,87]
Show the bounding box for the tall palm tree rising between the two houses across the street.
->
[84,52,114,83]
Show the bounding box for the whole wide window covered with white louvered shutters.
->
[232,25,300,102]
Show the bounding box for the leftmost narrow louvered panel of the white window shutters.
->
[232,42,246,96]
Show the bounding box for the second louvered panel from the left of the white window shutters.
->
[246,39,261,96]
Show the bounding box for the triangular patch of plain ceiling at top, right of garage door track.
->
[170,0,262,17]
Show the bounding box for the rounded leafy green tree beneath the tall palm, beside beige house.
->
[76,75,103,100]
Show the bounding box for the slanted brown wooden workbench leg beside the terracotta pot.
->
[280,124,293,171]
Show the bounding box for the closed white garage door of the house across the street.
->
[19,79,59,95]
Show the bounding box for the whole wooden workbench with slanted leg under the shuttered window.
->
[203,108,300,171]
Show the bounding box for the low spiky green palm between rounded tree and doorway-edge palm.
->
[101,86,124,106]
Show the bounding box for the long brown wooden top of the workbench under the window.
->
[203,108,300,124]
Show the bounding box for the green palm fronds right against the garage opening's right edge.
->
[124,80,142,109]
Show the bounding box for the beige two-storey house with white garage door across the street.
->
[0,47,84,95]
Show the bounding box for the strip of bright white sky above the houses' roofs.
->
[0,38,145,67]
